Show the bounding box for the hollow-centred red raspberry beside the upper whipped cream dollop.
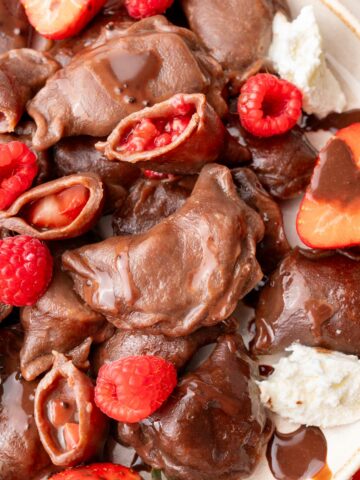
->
[238,73,302,137]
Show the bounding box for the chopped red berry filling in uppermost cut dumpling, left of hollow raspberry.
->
[117,102,195,153]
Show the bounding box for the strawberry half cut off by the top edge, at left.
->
[21,0,106,40]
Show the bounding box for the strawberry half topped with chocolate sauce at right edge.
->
[296,123,360,249]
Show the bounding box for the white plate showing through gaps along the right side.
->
[249,0,360,480]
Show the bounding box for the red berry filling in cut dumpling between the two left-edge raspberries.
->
[24,185,90,229]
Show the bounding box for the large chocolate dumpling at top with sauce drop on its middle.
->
[27,16,227,150]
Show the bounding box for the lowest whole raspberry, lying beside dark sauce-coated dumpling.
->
[95,355,177,423]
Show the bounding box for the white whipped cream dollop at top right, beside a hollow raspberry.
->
[269,6,346,118]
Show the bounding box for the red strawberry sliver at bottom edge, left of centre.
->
[51,463,141,480]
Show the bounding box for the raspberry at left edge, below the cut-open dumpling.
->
[0,235,53,307]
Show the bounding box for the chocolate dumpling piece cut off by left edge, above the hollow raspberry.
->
[0,48,60,133]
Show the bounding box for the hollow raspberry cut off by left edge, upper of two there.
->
[0,142,38,210]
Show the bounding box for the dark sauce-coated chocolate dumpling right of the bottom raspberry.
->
[118,335,272,480]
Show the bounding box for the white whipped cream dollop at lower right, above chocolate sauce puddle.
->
[258,344,360,428]
